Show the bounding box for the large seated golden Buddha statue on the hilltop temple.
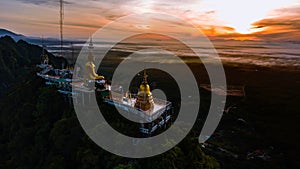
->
[84,51,104,80]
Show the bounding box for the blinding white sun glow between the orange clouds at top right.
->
[203,0,296,34]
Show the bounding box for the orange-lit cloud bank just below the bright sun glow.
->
[203,6,300,41]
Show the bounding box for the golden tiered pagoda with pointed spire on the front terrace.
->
[134,70,154,111]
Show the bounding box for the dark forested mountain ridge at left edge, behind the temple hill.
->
[0,36,67,97]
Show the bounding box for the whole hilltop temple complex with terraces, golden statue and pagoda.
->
[37,36,173,136]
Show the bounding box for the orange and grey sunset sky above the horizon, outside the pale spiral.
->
[0,0,300,41]
